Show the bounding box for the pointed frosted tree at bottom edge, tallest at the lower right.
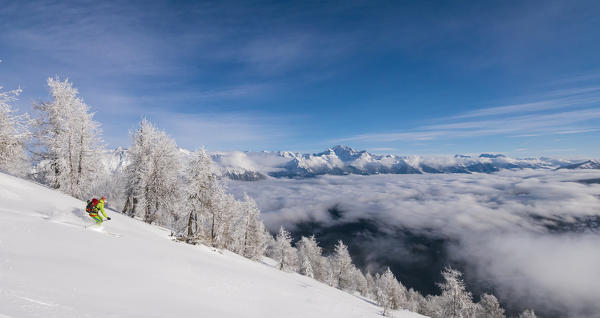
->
[439,267,476,318]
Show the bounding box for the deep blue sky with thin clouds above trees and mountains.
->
[0,0,600,157]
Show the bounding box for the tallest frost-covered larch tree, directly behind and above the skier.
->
[34,78,102,199]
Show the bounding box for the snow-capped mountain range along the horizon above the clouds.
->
[102,145,600,181]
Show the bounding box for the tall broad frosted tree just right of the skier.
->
[124,119,179,225]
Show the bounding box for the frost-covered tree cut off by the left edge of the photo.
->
[0,86,31,176]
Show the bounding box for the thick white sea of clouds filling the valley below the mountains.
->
[229,170,600,317]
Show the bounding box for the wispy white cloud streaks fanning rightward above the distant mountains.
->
[336,87,600,142]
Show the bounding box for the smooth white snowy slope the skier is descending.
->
[0,174,422,318]
